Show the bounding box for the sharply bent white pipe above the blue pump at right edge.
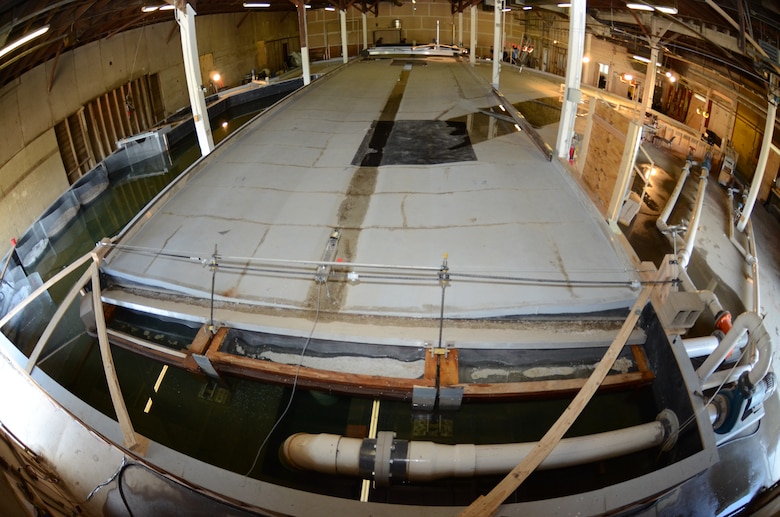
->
[696,312,772,387]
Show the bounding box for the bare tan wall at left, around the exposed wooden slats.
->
[0,13,298,250]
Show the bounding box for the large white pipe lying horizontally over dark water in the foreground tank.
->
[281,421,667,481]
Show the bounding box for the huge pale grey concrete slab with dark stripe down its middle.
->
[104,60,636,318]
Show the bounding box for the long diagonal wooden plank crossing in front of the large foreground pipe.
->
[460,286,653,517]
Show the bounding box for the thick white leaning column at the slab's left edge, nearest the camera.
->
[176,4,214,156]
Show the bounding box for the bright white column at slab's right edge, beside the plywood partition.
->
[556,0,586,158]
